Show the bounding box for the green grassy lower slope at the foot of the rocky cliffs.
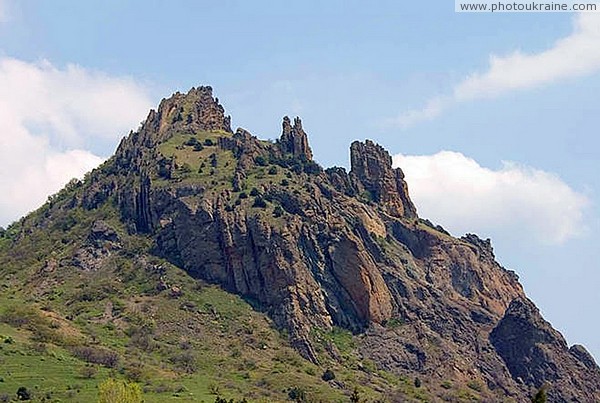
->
[0,196,394,403]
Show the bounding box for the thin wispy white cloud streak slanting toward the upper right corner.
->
[391,13,600,128]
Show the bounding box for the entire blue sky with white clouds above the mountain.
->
[0,0,600,357]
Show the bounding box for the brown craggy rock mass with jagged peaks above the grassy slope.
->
[19,87,600,401]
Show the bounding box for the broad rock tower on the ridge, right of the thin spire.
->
[350,140,417,218]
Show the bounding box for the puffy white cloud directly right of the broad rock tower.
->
[393,151,590,244]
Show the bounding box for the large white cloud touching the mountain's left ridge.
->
[0,56,151,225]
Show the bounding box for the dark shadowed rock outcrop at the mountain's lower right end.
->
[490,298,600,402]
